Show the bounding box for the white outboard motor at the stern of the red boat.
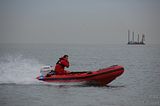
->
[40,66,53,77]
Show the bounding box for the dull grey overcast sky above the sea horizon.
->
[0,0,160,44]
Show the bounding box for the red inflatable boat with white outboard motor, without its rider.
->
[37,65,124,85]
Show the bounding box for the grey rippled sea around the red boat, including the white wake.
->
[0,44,160,106]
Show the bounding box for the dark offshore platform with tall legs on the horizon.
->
[127,30,145,45]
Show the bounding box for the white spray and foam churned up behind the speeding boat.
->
[0,55,42,84]
